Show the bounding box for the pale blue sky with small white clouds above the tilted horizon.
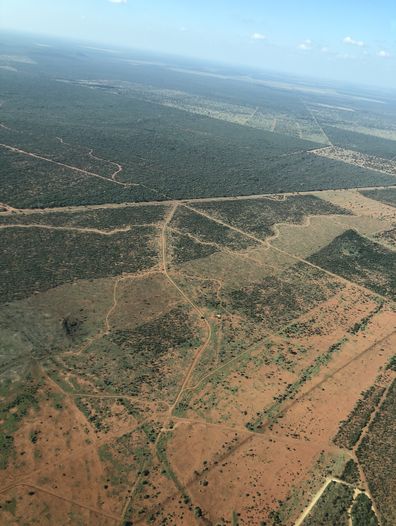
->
[0,0,396,88]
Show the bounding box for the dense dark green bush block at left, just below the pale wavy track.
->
[0,227,158,302]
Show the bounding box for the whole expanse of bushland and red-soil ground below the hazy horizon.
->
[0,34,396,526]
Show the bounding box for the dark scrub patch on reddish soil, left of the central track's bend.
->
[65,308,200,400]
